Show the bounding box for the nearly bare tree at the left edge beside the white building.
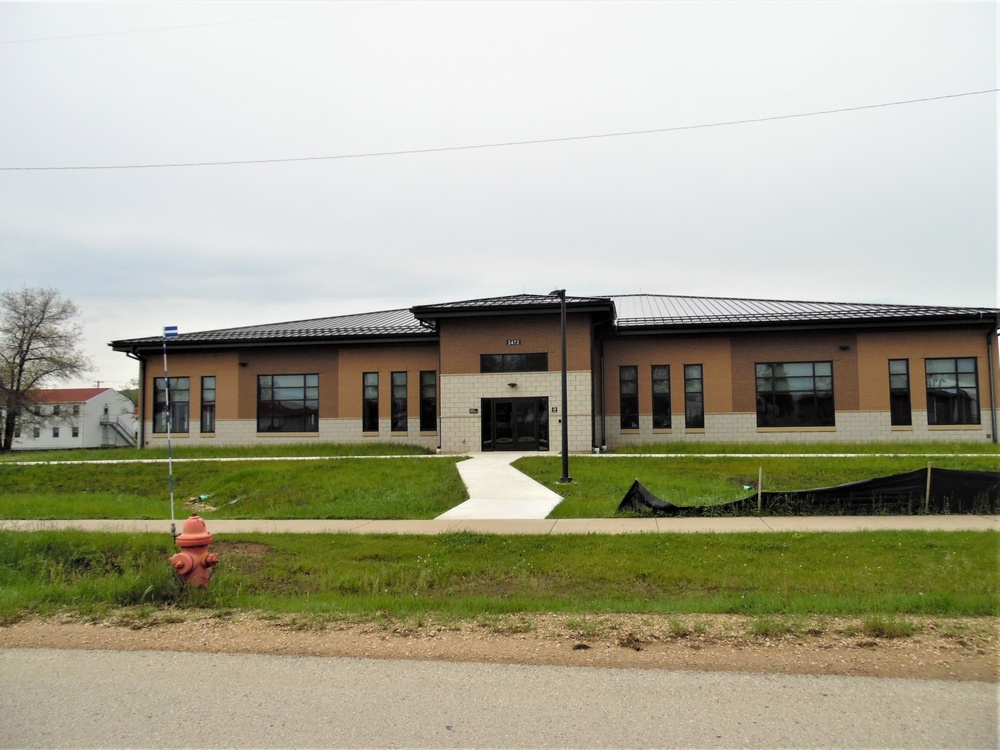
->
[0,287,91,452]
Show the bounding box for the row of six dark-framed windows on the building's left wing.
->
[153,370,437,433]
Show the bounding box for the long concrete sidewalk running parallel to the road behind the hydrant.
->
[0,516,1000,538]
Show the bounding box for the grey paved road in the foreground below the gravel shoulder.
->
[0,649,997,748]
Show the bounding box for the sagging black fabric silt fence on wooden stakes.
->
[617,469,1000,516]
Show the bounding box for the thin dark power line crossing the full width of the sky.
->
[0,89,1000,172]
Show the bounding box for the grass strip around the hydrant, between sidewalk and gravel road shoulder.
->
[0,530,1000,622]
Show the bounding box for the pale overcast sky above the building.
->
[0,1,998,394]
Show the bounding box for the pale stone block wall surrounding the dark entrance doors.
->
[440,371,592,453]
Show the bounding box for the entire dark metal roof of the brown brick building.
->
[111,294,1000,351]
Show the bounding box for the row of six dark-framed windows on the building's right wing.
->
[618,357,979,430]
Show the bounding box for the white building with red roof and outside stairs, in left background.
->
[11,388,137,451]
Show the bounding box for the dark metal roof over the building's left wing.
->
[111,310,437,351]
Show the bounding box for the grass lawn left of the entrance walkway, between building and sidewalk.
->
[0,457,468,519]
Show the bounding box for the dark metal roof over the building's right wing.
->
[610,294,1000,330]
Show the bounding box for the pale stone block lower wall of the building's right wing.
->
[598,411,992,448]
